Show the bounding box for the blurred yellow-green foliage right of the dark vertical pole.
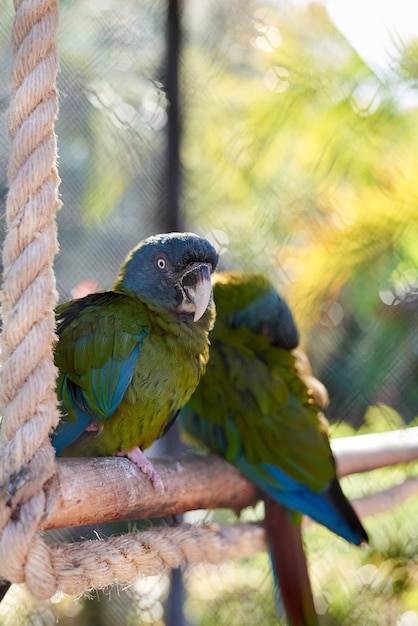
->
[183,2,418,426]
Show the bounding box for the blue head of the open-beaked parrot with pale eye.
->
[114,233,218,322]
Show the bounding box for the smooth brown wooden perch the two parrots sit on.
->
[42,428,418,529]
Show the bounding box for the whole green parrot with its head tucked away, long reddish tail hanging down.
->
[180,271,368,626]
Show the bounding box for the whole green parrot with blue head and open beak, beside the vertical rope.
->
[52,233,218,489]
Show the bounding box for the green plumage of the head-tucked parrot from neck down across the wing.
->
[185,272,335,492]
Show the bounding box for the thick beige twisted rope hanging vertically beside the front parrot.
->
[0,0,60,595]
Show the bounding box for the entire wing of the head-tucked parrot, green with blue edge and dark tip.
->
[182,328,365,543]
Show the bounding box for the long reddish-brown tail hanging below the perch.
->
[264,497,319,626]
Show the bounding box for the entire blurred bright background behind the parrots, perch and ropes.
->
[0,0,418,626]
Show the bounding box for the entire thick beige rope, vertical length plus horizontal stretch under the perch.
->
[0,0,264,599]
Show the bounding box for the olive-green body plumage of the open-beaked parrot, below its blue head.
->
[55,292,211,456]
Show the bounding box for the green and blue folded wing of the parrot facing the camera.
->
[52,292,148,454]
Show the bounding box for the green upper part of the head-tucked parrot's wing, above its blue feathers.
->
[183,328,334,491]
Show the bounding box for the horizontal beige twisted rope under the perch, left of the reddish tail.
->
[49,524,265,595]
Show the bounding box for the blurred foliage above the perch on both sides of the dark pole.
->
[0,0,418,426]
